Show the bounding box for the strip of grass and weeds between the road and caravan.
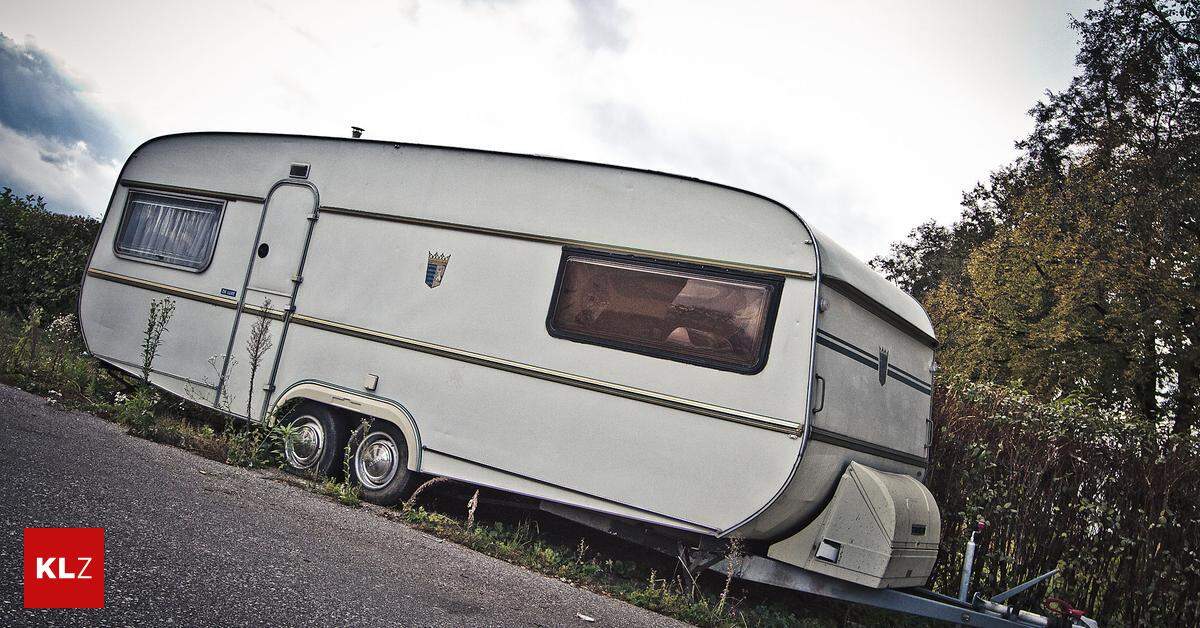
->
[0,313,922,628]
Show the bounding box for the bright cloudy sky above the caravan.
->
[0,0,1090,258]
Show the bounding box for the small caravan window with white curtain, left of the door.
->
[116,192,224,271]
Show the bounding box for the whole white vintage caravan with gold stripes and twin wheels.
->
[79,133,941,588]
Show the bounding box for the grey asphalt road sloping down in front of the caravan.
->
[0,385,683,627]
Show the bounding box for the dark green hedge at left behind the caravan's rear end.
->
[0,187,100,316]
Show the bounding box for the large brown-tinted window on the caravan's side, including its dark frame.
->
[550,252,780,372]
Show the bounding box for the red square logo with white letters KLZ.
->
[25,527,104,609]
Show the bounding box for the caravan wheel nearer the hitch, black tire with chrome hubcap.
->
[347,419,416,506]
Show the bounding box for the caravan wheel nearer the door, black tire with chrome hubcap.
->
[283,401,347,478]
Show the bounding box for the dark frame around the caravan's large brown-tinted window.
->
[546,246,784,375]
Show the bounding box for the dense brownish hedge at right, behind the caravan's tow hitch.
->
[930,379,1200,626]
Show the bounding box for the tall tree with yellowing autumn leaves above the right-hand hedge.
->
[875,0,1200,432]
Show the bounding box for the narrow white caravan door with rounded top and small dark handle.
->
[216,179,320,420]
